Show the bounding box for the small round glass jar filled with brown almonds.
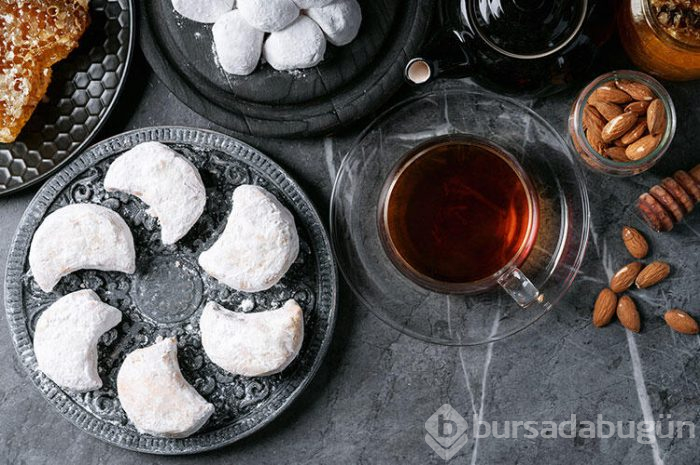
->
[569,71,676,176]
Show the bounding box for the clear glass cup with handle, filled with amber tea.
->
[377,134,542,307]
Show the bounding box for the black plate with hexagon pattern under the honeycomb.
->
[0,0,135,196]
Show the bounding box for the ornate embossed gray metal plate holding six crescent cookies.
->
[5,128,337,454]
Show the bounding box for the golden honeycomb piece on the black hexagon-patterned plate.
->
[0,0,89,142]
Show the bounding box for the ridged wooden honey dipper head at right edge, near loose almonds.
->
[637,165,700,231]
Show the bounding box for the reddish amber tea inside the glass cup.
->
[384,139,536,283]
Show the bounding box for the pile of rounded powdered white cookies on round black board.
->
[173,0,362,75]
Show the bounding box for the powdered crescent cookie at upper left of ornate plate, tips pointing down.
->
[29,203,136,292]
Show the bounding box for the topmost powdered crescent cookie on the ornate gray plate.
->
[104,142,207,244]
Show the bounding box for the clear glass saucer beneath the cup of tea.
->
[330,89,589,346]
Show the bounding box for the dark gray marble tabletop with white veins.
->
[0,44,700,465]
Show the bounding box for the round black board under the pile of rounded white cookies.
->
[139,0,433,137]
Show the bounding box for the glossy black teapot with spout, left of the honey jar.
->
[405,0,614,95]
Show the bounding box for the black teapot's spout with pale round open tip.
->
[404,30,473,85]
